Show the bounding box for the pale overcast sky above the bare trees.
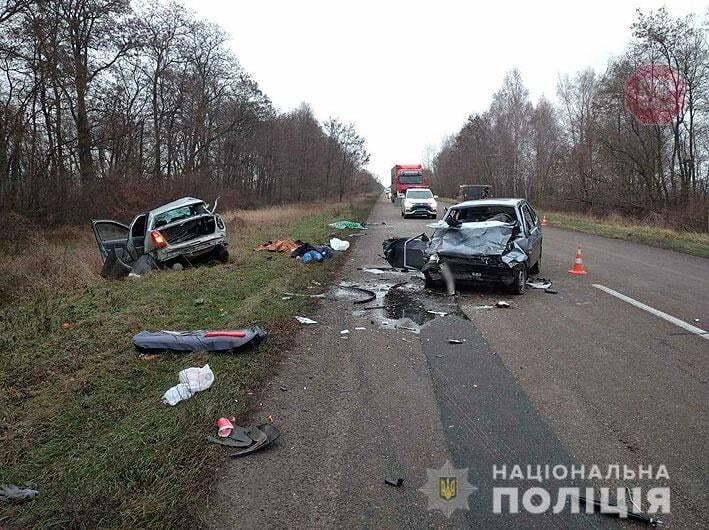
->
[187,0,709,182]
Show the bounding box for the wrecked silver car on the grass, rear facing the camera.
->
[91,197,229,278]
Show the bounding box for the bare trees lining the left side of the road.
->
[0,0,378,223]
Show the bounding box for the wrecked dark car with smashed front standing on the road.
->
[383,199,542,294]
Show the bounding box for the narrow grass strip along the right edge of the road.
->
[540,211,709,258]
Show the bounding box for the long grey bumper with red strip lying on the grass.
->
[133,326,267,353]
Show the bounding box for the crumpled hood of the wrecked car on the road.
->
[427,221,527,267]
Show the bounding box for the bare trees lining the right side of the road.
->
[429,9,709,230]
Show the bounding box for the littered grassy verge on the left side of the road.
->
[0,194,373,527]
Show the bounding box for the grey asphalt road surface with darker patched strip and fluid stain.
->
[205,199,709,528]
